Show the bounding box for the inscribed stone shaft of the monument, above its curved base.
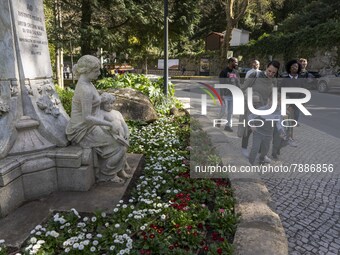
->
[0,0,68,158]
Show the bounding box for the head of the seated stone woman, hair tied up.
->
[73,55,100,79]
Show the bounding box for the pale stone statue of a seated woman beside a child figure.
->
[66,55,131,182]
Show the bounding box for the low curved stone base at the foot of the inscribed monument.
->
[0,146,95,217]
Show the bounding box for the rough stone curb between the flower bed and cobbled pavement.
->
[195,116,288,255]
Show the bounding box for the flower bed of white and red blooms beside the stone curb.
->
[0,117,237,255]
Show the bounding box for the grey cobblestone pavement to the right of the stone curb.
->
[175,82,340,255]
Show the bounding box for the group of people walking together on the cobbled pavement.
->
[217,57,313,165]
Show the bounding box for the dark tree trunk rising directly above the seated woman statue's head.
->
[80,0,92,55]
